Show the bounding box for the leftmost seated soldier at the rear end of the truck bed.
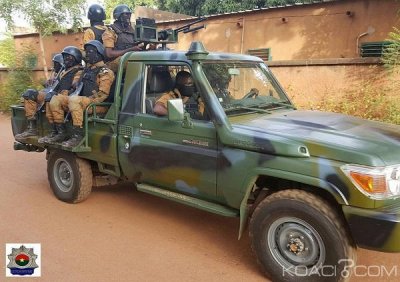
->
[15,54,71,140]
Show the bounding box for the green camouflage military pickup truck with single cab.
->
[12,42,400,281]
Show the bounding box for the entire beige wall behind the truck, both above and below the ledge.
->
[4,0,400,109]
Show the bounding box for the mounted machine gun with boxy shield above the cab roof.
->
[135,17,207,50]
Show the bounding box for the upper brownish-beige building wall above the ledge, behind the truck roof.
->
[160,0,400,60]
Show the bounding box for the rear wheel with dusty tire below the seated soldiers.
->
[47,151,93,203]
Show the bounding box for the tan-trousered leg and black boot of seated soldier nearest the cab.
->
[62,96,92,147]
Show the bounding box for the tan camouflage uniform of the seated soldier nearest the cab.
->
[67,61,114,127]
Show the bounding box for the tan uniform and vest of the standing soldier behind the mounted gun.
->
[102,23,135,73]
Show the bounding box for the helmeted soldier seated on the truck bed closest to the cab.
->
[62,40,114,147]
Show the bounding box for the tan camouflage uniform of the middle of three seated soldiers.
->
[46,65,82,123]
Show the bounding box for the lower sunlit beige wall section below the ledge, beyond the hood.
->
[271,64,394,108]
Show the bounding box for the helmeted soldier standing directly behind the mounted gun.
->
[103,5,142,72]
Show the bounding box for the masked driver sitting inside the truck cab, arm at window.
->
[153,71,204,119]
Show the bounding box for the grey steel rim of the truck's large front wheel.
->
[267,217,326,274]
